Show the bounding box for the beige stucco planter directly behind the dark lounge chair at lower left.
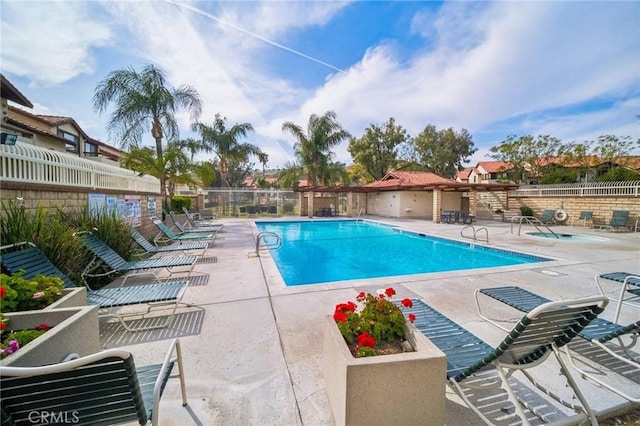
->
[0,306,100,367]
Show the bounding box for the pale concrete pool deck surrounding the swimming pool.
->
[106,217,640,426]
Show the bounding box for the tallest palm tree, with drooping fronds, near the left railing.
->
[93,64,202,206]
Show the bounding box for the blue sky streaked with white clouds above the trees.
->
[0,0,640,168]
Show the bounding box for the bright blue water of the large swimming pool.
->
[256,220,551,286]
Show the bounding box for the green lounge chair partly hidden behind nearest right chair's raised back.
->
[476,286,640,402]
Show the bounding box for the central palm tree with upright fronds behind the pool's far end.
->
[282,111,350,186]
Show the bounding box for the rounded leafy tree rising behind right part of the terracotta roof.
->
[401,124,477,178]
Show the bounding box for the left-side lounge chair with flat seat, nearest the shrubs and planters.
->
[0,242,189,331]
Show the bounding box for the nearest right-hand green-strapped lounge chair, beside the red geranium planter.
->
[407,296,607,424]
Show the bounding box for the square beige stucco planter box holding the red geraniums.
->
[324,315,446,426]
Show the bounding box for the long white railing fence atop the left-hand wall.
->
[0,142,160,193]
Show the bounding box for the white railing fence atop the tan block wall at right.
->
[509,180,640,197]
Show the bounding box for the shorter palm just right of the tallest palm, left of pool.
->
[193,114,266,187]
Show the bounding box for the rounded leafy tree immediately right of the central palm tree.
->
[348,117,410,180]
